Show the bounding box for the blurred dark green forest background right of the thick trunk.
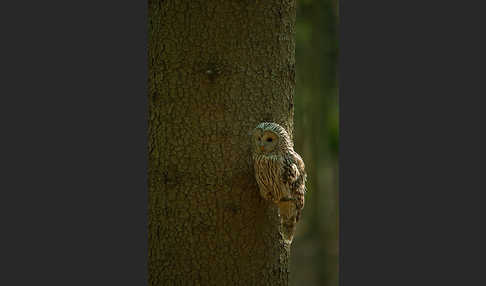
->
[290,0,339,286]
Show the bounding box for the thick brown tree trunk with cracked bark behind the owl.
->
[148,0,295,285]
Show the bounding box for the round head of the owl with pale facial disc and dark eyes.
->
[253,122,292,155]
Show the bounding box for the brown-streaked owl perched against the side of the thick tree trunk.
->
[252,122,306,243]
